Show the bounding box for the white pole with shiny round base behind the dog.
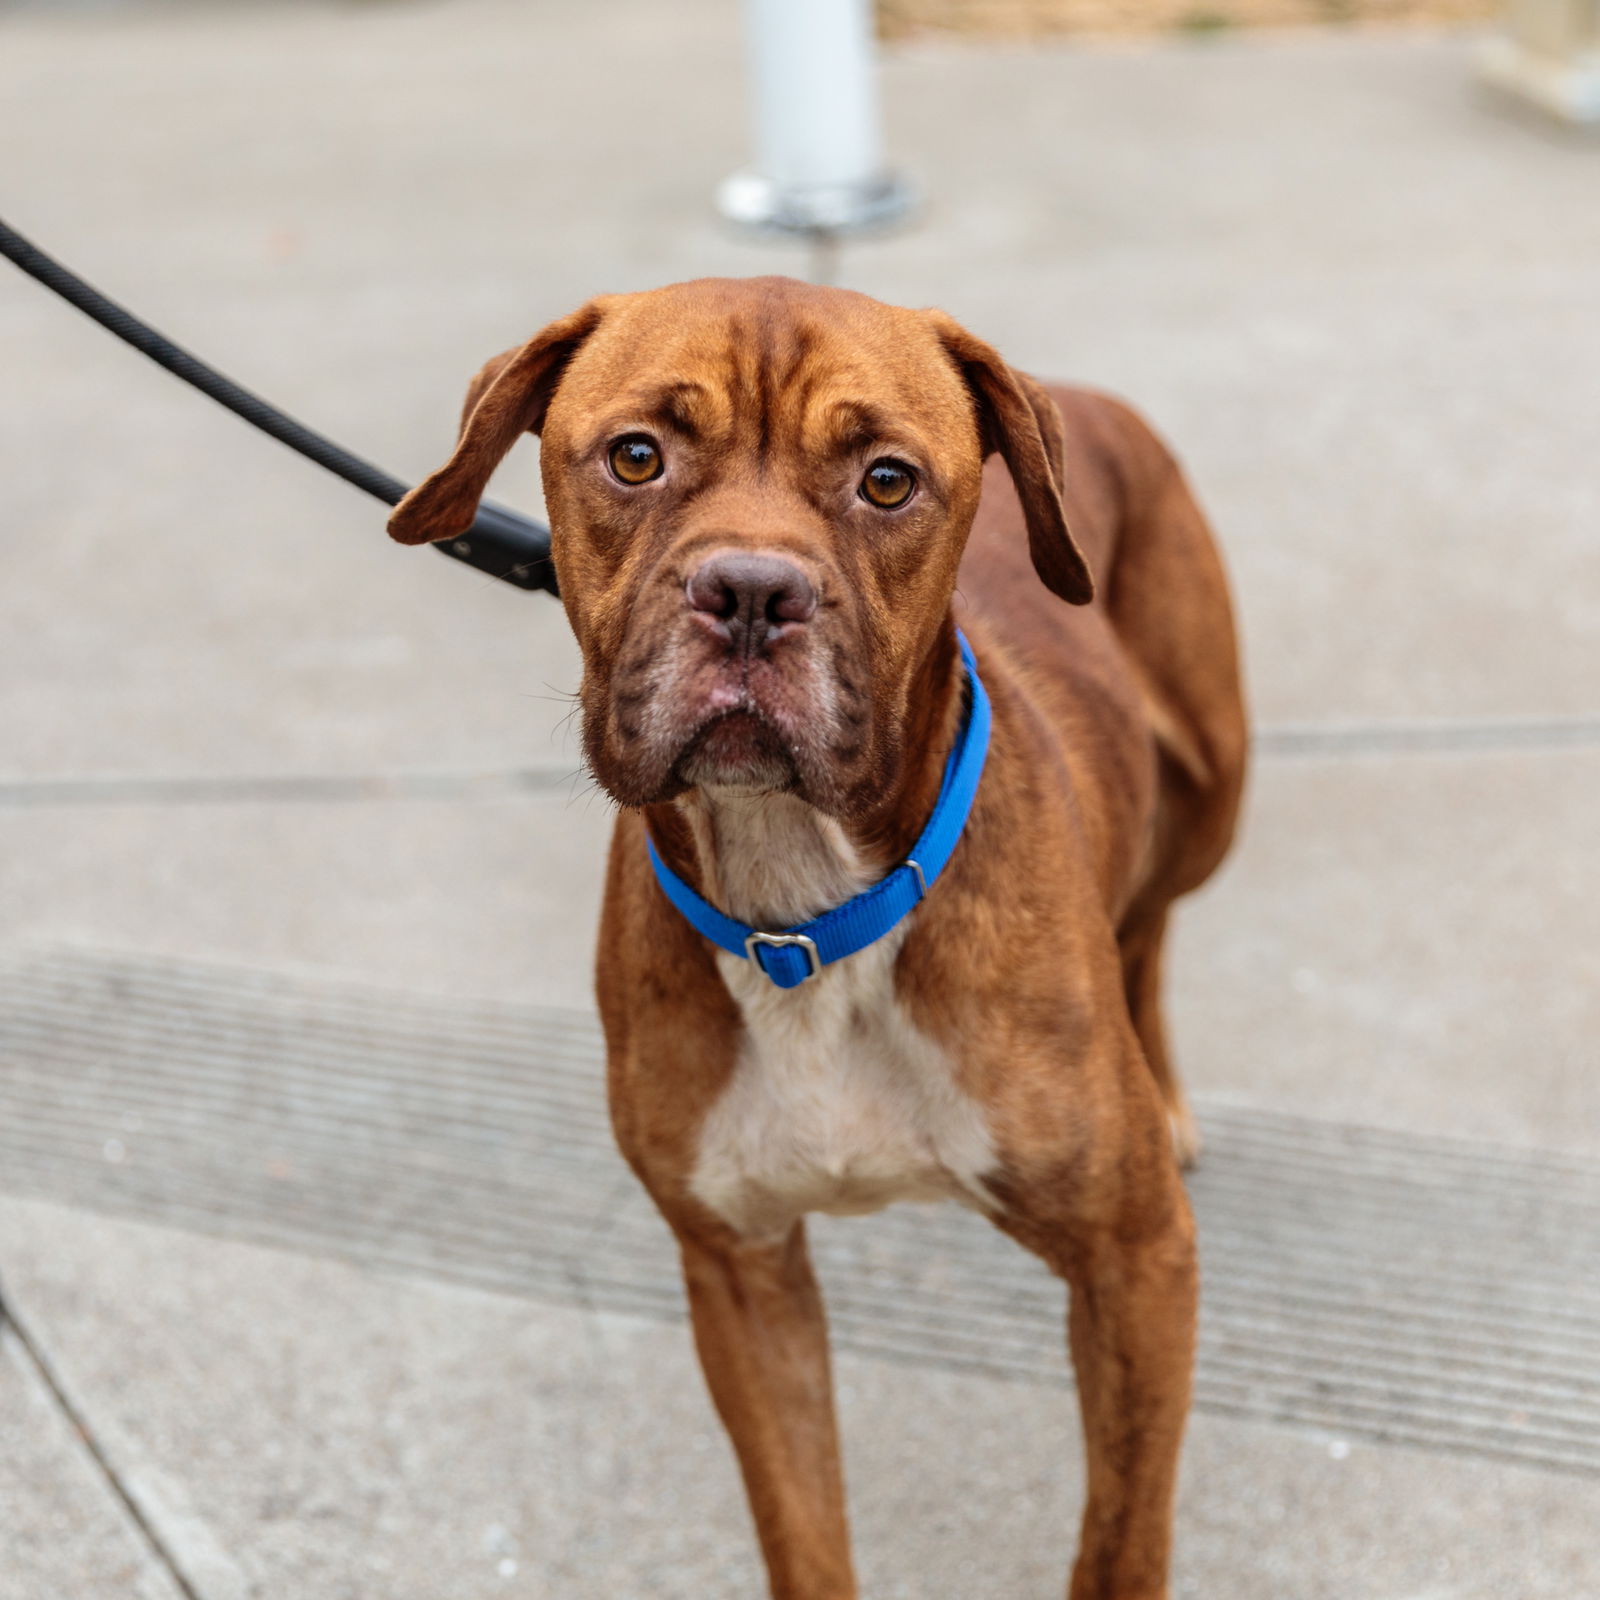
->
[717,0,909,234]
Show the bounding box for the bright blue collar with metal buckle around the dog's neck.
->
[646,632,989,989]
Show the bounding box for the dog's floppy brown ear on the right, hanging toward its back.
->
[931,312,1094,605]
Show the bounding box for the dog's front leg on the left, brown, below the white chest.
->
[678,1222,856,1600]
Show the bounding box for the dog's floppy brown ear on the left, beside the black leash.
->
[389,301,602,544]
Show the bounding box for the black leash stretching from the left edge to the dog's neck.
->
[0,221,555,594]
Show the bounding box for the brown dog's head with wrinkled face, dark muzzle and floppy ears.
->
[390,278,1091,818]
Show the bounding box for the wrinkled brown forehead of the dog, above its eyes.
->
[544,278,978,469]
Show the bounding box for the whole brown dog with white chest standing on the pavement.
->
[390,278,1245,1600]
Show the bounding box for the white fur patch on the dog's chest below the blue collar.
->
[691,930,995,1237]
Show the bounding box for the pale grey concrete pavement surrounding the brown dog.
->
[0,0,1600,1600]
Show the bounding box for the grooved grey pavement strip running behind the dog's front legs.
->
[0,949,1600,1475]
